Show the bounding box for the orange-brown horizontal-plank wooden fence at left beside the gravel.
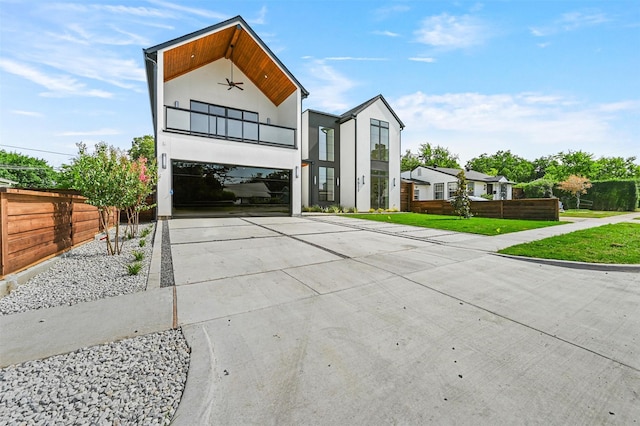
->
[0,188,112,277]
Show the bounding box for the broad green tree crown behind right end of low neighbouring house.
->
[465,150,535,182]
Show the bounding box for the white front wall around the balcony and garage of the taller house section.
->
[155,36,302,216]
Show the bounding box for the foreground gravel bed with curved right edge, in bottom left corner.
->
[0,330,189,426]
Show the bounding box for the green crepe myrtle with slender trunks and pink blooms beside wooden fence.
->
[63,142,157,255]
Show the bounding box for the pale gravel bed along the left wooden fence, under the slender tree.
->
[0,224,155,315]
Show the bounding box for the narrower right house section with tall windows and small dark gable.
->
[302,95,404,211]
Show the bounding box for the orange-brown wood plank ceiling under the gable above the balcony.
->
[164,24,296,106]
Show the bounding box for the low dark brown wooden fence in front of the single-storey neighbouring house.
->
[407,198,560,220]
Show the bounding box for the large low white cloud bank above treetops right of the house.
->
[391,92,640,160]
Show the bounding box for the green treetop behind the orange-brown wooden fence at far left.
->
[0,149,58,188]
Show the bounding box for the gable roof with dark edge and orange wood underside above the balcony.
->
[143,16,309,109]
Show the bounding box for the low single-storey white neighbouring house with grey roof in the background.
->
[401,166,513,201]
